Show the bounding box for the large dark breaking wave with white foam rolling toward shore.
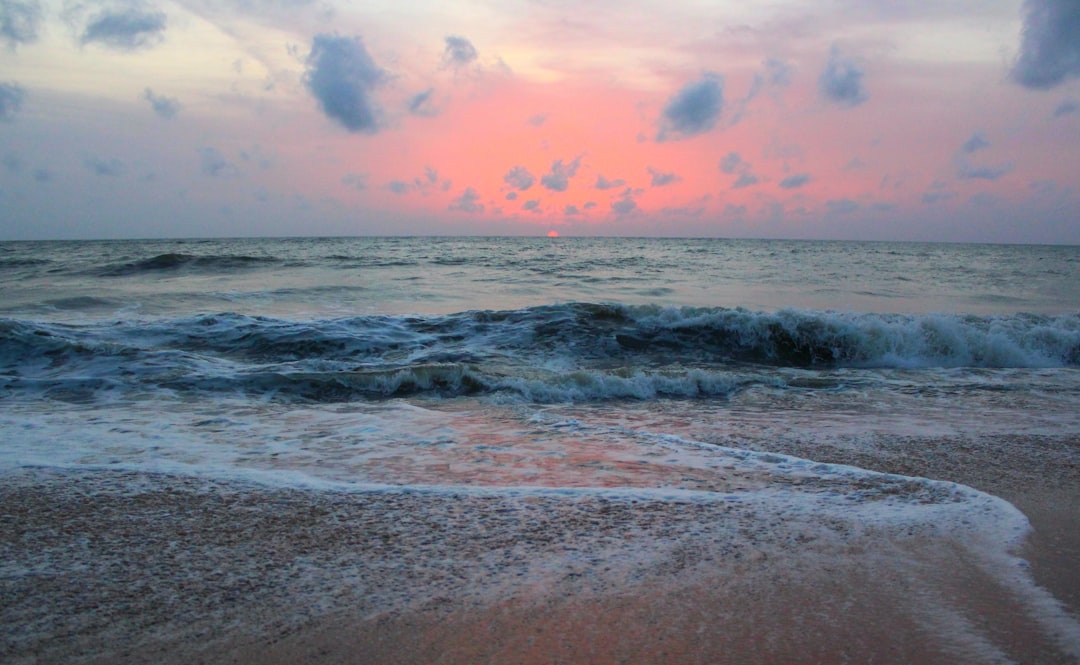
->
[0,303,1080,403]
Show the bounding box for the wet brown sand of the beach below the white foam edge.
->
[0,437,1080,665]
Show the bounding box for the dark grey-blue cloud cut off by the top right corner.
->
[1012,0,1080,90]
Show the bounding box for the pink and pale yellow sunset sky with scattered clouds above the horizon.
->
[0,0,1080,244]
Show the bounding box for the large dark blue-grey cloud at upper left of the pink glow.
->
[303,35,387,134]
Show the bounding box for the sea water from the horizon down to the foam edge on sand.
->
[6,238,1080,648]
